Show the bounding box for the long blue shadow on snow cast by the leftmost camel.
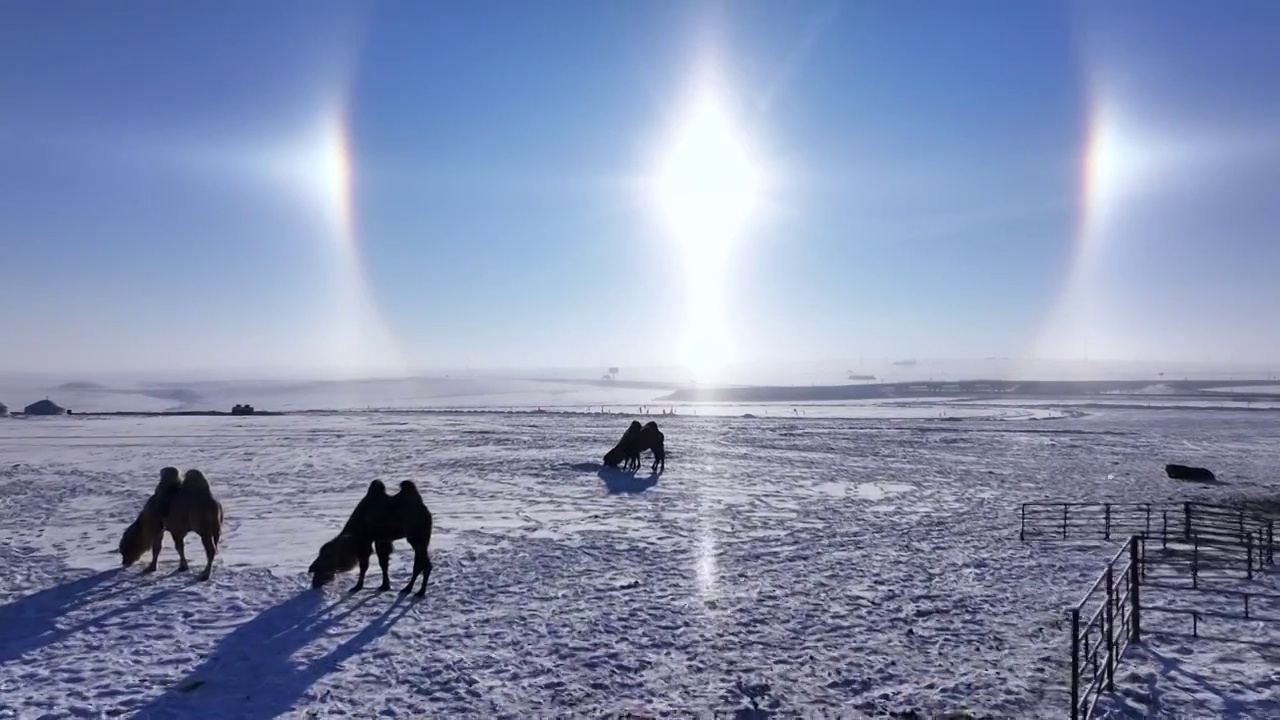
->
[0,568,178,665]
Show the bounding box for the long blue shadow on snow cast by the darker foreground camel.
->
[134,591,413,720]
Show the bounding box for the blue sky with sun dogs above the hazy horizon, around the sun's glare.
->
[0,0,1280,375]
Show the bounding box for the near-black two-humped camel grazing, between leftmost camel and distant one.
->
[307,480,431,597]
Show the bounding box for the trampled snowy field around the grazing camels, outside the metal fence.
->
[0,407,1280,719]
